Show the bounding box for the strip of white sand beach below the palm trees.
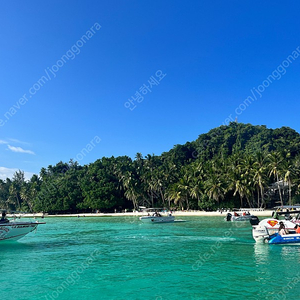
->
[8,210,273,218]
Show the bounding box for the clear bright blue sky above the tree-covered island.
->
[0,0,300,179]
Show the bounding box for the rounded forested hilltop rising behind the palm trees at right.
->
[162,122,300,163]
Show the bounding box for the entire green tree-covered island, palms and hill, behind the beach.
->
[0,122,300,213]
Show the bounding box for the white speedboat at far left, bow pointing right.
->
[0,214,46,241]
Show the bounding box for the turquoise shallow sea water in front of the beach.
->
[0,217,300,300]
